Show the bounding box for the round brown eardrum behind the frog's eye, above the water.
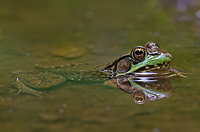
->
[117,57,131,73]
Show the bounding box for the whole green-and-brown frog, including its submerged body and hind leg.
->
[12,41,183,97]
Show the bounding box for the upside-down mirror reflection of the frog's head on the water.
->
[110,75,172,104]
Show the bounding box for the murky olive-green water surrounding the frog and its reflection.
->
[0,0,200,132]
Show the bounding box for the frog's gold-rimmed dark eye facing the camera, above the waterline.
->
[131,46,147,60]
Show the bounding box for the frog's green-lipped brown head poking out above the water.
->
[101,41,173,76]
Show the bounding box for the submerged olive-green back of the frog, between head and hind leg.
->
[39,63,108,81]
